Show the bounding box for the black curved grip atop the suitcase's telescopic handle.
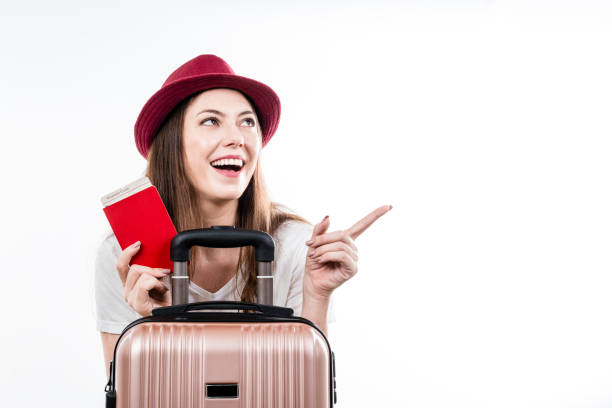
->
[170,225,274,262]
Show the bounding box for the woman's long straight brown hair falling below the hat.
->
[146,93,312,302]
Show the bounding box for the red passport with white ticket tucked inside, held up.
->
[102,177,176,269]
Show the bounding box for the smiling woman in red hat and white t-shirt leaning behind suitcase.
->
[96,55,391,376]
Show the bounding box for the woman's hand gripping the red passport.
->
[117,241,172,316]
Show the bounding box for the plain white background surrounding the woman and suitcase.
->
[0,0,612,408]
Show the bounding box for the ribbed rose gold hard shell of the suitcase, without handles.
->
[115,321,333,408]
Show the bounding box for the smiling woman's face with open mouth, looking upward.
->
[183,88,261,203]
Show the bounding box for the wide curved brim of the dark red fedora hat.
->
[134,74,280,158]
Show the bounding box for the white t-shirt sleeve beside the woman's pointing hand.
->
[283,222,336,324]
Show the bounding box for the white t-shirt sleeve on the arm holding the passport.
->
[94,234,142,334]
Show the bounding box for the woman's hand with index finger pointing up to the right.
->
[303,205,392,299]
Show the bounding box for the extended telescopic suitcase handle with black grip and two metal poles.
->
[170,225,274,305]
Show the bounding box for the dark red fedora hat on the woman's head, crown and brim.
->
[134,54,280,159]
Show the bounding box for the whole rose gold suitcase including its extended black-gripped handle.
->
[106,226,336,408]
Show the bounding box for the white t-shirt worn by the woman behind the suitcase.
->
[95,220,335,334]
